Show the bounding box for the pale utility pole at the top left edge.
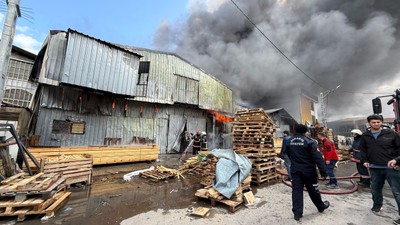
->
[0,0,21,105]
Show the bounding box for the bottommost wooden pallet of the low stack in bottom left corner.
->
[0,191,71,221]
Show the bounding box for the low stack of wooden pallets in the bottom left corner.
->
[0,173,71,221]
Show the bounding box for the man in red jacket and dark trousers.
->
[318,132,339,188]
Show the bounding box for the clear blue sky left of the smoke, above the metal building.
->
[0,0,188,53]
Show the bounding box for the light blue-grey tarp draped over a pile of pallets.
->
[211,149,251,198]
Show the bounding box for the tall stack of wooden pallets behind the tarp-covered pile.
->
[233,108,279,185]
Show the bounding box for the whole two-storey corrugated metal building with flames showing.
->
[31,30,232,153]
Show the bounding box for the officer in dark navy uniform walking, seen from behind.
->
[286,124,329,220]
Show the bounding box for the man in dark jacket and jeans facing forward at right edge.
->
[360,115,400,224]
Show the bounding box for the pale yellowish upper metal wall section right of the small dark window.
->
[126,49,233,113]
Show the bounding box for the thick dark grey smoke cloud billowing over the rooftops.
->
[154,0,400,119]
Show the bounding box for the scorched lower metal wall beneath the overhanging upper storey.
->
[35,86,207,153]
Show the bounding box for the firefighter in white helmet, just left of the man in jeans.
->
[349,129,371,187]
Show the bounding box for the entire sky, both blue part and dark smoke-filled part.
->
[0,0,400,120]
